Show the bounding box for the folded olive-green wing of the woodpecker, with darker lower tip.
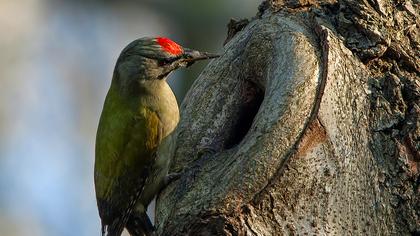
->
[95,89,162,230]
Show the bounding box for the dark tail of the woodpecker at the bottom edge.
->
[125,211,155,236]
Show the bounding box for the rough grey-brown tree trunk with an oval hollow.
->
[157,0,420,235]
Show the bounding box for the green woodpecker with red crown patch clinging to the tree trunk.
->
[94,37,217,236]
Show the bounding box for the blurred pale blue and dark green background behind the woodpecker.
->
[0,0,261,236]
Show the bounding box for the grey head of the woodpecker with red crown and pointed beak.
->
[115,37,218,81]
